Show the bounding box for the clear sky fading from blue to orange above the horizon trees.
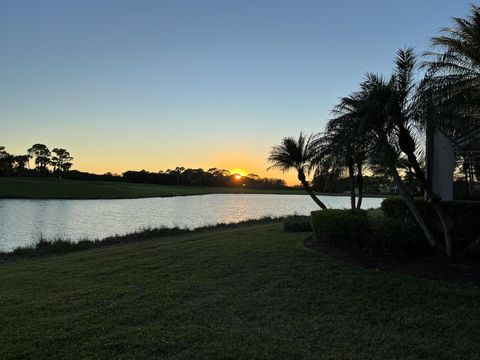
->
[0,0,470,184]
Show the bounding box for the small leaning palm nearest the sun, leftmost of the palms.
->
[268,133,327,210]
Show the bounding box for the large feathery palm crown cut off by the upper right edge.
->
[422,4,480,148]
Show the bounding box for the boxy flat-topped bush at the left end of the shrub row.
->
[312,209,369,248]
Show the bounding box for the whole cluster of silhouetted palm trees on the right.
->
[268,5,480,256]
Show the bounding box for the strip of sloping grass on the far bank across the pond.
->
[0,178,305,199]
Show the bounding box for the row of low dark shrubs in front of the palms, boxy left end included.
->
[312,210,429,259]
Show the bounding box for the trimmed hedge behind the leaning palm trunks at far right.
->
[381,197,480,251]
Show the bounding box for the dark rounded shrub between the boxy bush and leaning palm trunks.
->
[364,216,430,259]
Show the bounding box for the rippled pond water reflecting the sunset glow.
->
[0,194,382,251]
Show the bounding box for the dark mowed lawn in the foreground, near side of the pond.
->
[0,223,480,359]
